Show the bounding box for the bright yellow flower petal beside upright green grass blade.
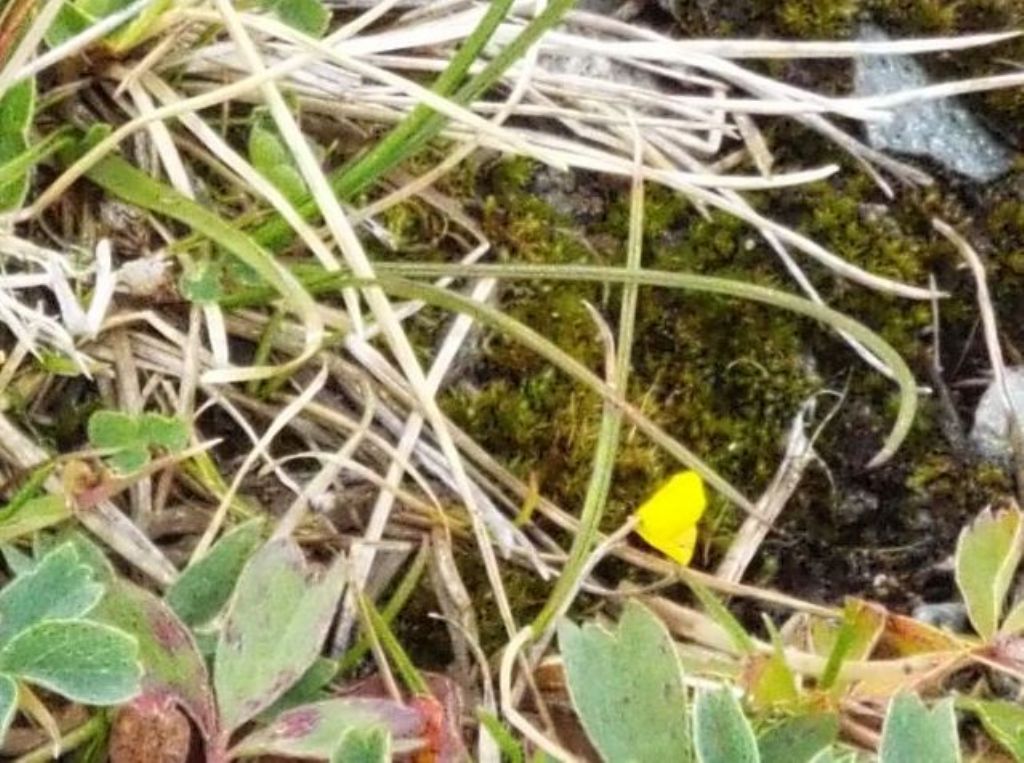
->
[636,471,708,565]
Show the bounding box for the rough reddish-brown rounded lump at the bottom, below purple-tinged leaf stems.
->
[109,694,191,763]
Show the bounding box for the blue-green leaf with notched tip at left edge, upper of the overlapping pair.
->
[0,544,103,646]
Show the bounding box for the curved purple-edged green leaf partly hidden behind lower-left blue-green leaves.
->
[93,580,217,738]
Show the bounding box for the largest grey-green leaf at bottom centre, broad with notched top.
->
[558,601,690,763]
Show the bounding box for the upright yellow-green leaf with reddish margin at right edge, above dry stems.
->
[956,507,1024,640]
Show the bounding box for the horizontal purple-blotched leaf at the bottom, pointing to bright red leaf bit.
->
[231,696,424,759]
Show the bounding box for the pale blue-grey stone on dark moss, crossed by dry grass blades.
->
[853,25,1014,182]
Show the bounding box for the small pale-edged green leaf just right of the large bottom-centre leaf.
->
[693,686,760,763]
